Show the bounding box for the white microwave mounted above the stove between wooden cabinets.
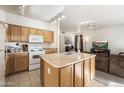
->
[29,35,44,43]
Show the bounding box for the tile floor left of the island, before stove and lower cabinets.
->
[6,70,41,87]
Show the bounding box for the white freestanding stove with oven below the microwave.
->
[29,44,45,70]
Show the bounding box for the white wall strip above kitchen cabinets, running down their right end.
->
[0,10,57,47]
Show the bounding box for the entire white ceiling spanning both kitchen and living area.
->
[0,5,124,31]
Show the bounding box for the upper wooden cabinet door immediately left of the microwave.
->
[21,27,29,42]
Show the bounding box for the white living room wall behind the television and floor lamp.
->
[83,25,124,54]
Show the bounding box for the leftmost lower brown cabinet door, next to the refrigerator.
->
[5,54,15,75]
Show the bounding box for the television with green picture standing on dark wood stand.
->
[92,41,108,50]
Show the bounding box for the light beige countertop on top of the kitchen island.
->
[40,53,96,68]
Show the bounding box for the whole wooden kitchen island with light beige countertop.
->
[40,53,95,87]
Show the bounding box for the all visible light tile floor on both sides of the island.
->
[6,70,124,87]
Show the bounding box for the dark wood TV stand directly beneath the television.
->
[91,48,110,72]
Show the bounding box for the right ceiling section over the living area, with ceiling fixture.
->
[61,5,124,31]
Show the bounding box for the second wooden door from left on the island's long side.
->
[75,62,84,87]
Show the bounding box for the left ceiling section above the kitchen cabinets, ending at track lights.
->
[0,5,64,21]
